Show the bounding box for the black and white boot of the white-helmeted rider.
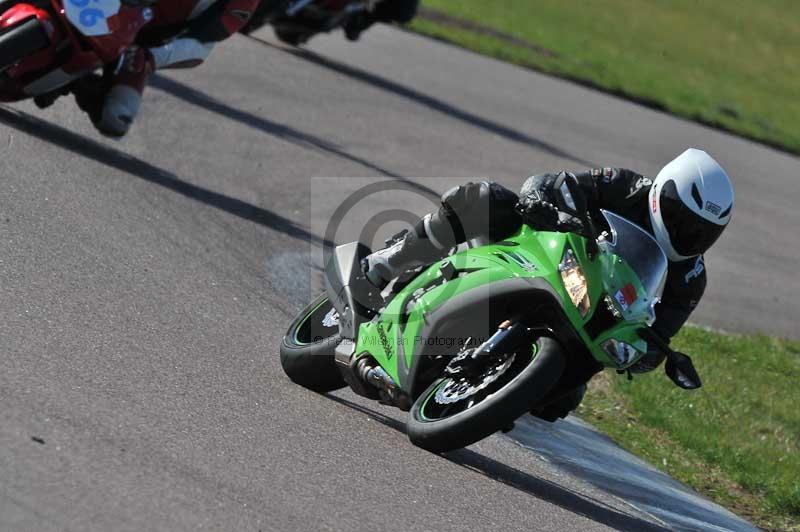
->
[363,215,450,289]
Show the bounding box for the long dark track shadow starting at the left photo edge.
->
[0,106,332,246]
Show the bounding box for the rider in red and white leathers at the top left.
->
[73,0,260,137]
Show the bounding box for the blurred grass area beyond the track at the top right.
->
[411,0,800,153]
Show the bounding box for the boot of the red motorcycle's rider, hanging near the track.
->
[94,47,155,137]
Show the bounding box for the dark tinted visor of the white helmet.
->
[660,180,725,257]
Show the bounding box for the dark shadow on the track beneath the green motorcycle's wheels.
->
[325,394,669,532]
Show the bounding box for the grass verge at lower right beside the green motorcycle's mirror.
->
[578,327,800,531]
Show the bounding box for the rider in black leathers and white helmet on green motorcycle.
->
[364,148,734,421]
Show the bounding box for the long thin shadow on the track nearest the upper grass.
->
[247,35,596,167]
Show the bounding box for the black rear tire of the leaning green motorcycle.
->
[281,294,346,393]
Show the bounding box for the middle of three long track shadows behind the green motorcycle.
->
[149,75,439,198]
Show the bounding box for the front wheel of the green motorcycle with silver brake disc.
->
[407,337,565,453]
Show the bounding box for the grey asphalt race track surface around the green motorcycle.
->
[0,22,800,531]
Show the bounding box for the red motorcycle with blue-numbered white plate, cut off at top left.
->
[0,0,154,107]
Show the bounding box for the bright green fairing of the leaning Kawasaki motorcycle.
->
[356,222,647,388]
